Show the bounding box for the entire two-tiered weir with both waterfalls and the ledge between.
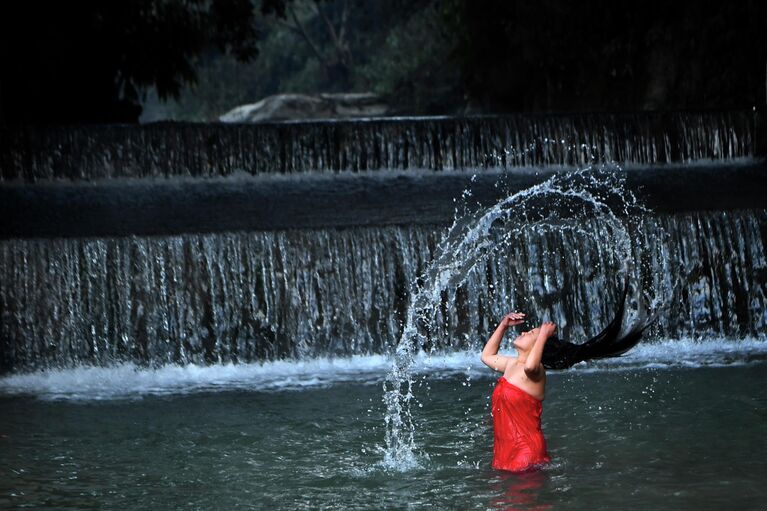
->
[0,112,767,371]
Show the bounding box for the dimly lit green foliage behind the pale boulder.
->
[145,0,462,121]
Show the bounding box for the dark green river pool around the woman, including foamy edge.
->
[0,339,767,509]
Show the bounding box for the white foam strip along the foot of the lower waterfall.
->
[0,339,767,400]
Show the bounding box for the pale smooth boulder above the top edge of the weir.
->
[219,92,389,122]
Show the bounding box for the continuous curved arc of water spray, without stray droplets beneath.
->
[383,166,646,470]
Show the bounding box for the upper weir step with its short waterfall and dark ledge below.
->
[0,112,767,239]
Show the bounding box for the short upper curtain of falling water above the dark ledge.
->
[0,112,756,181]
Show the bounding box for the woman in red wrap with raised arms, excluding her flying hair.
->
[482,312,556,472]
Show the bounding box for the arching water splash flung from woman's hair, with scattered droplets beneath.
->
[383,165,669,470]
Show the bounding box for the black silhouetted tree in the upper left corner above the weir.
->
[0,0,260,125]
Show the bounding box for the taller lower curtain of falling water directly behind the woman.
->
[0,210,767,370]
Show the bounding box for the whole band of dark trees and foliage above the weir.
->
[0,0,767,126]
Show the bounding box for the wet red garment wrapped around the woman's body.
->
[492,376,551,472]
